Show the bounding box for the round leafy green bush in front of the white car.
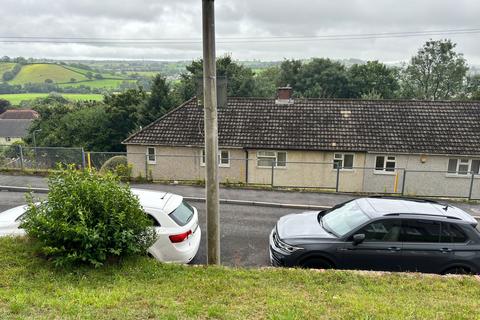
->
[21,167,156,267]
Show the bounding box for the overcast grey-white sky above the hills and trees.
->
[0,0,480,64]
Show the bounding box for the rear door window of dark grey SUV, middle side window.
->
[401,219,440,243]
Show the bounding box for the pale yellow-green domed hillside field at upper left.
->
[9,63,88,84]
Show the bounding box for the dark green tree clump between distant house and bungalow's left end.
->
[25,90,145,151]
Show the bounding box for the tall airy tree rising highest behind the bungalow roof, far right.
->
[402,40,468,100]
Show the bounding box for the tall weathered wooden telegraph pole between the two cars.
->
[202,0,220,264]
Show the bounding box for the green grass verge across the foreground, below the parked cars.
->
[0,238,480,319]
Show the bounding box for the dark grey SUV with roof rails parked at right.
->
[270,197,480,274]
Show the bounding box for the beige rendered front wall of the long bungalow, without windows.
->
[127,145,480,199]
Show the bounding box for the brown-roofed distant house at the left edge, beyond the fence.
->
[0,109,38,145]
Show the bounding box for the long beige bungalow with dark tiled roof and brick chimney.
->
[124,88,480,197]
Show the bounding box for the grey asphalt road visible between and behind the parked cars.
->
[0,192,302,267]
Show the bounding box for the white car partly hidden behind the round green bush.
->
[0,189,201,263]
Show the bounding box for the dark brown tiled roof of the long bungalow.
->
[124,98,480,155]
